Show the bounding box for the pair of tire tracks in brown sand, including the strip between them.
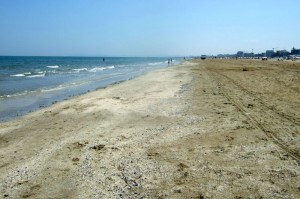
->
[204,67,300,164]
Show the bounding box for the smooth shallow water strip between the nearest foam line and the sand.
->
[0,62,180,123]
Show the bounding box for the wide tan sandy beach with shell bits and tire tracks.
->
[0,60,300,198]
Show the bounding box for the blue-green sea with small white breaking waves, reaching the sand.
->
[0,56,183,122]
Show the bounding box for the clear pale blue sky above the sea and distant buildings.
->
[0,0,300,56]
